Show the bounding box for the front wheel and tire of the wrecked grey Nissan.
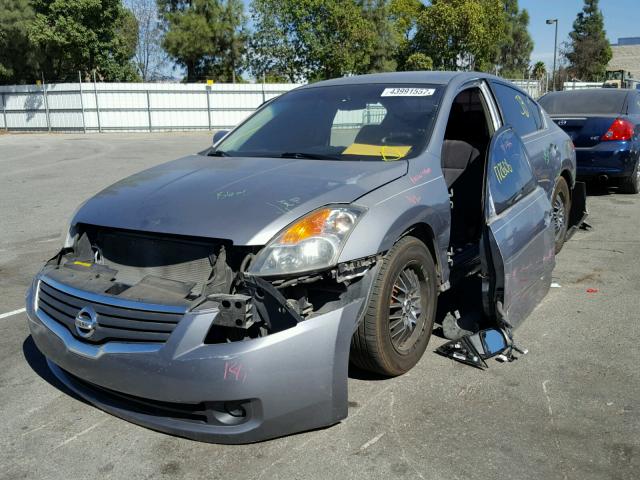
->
[350,236,437,376]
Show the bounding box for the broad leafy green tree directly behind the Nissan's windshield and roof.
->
[250,0,380,81]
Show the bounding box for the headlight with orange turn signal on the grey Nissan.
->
[249,205,365,276]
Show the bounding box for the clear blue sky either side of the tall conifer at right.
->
[519,0,640,67]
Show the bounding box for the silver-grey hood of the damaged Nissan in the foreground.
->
[72,155,408,245]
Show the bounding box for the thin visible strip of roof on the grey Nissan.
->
[302,71,504,88]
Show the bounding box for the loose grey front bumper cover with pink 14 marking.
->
[26,276,365,443]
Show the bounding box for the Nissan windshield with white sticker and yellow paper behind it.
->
[210,84,443,161]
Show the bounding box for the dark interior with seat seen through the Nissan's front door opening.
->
[442,87,493,275]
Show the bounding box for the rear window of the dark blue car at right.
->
[538,88,627,115]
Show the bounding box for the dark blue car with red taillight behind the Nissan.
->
[539,88,640,193]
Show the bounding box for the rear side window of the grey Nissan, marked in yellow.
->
[491,82,542,137]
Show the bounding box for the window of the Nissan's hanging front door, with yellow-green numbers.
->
[488,129,536,215]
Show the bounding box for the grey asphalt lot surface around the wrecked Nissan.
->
[0,132,640,480]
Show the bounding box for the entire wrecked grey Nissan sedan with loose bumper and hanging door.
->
[27,72,585,443]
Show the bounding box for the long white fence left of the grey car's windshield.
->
[0,82,298,131]
